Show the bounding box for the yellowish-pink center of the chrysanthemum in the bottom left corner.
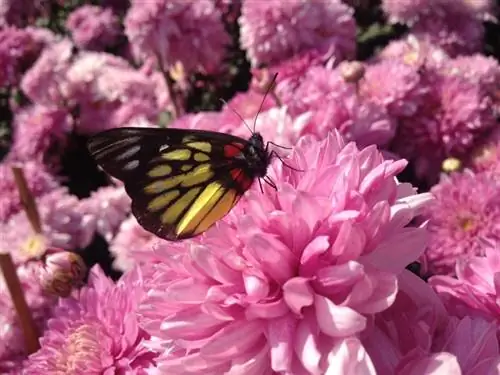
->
[55,324,103,374]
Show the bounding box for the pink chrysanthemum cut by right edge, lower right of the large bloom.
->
[429,241,500,322]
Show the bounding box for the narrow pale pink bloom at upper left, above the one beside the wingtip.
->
[21,39,74,106]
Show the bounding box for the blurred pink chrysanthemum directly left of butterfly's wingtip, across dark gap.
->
[8,105,72,170]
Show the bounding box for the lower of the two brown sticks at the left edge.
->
[0,253,40,354]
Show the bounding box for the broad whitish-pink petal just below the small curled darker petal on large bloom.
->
[314,294,366,337]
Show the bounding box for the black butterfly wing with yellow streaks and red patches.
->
[88,128,253,240]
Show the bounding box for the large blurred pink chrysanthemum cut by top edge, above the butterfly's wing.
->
[125,0,230,74]
